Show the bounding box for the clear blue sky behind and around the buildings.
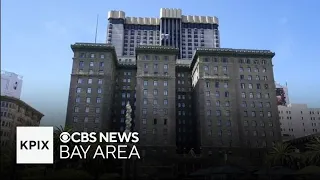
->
[1,0,320,126]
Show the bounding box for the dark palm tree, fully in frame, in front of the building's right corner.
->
[267,143,296,166]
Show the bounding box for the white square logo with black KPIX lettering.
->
[16,127,53,164]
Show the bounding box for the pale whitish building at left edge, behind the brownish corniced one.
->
[1,71,22,99]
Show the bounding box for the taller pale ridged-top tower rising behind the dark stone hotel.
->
[107,8,220,58]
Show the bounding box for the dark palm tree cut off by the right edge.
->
[306,137,320,165]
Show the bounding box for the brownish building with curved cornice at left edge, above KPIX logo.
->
[0,96,44,146]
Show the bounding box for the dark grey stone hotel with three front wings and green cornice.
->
[66,43,281,152]
